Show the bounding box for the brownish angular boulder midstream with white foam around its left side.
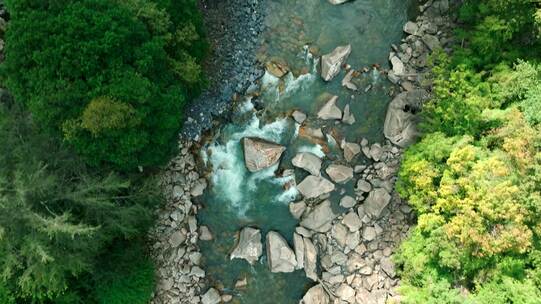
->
[243,137,286,172]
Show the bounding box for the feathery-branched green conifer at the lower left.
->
[0,105,160,303]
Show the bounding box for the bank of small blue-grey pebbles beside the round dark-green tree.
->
[182,0,265,140]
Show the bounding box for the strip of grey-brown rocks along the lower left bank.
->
[150,142,220,304]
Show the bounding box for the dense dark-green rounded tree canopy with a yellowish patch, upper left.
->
[3,0,207,171]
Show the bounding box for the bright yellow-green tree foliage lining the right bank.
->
[394,0,541,304]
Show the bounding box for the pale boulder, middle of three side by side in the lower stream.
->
[267,231,297,272]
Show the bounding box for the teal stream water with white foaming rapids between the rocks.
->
[198,0,415,304]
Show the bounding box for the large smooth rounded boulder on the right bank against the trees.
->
[383,90,426,147]
